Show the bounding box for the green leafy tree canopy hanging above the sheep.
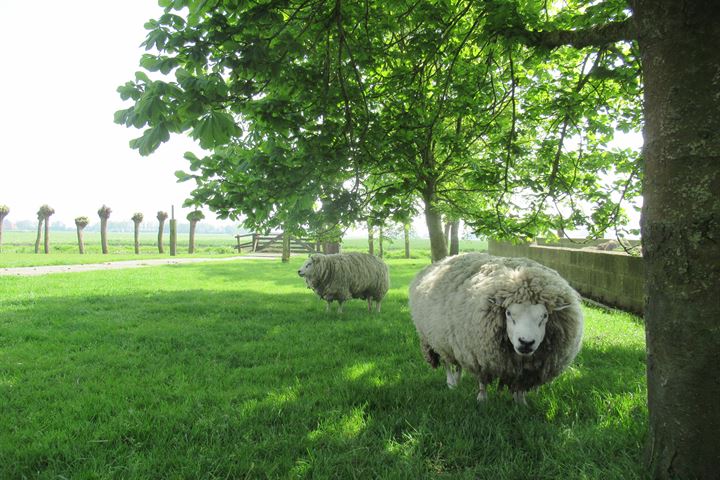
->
[115,0,641,240]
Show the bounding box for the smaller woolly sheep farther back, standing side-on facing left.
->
[298,253,390,313]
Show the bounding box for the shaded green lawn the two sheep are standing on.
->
[0,257,647,480]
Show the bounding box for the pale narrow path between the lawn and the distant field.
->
[0,254,280,276]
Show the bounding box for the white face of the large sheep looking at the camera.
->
[505,303,548,356]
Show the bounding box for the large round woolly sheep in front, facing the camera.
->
[410,253,583,404]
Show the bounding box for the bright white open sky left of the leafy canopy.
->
[0,0,220,225]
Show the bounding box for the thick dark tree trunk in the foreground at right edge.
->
[631,0,720,479]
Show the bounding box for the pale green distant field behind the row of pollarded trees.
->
[0,231,487,268]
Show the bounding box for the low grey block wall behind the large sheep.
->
[488,239,644,314]
